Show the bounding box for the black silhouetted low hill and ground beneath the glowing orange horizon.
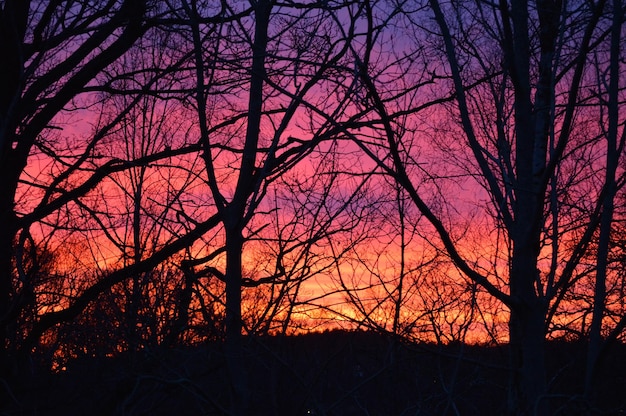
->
[2,331,626,416]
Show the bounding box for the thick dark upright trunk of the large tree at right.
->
[502,0,558,408]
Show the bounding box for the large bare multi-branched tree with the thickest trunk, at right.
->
[344,0,623,414]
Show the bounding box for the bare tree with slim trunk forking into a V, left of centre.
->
[182,0,378,414]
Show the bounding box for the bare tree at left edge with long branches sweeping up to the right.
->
[0,1,218,374]
